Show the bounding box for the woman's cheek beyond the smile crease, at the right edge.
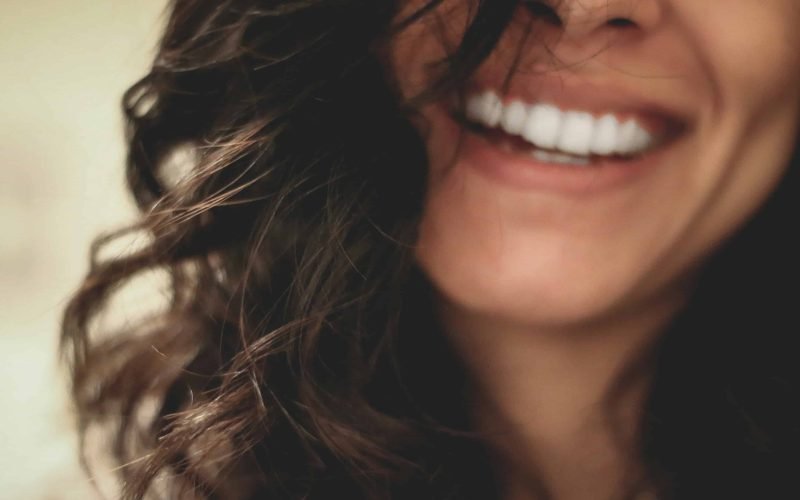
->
[684,0,800,246]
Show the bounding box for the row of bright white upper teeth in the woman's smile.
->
[466,91,656,156]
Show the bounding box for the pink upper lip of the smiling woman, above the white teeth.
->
[465,72,696,135]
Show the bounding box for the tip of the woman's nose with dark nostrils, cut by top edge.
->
[528,0,662,40]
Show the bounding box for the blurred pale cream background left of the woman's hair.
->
[0,0,165,500]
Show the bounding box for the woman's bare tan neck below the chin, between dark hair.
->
[442,292,680,500]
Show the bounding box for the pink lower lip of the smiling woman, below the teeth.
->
[448,118,669,196]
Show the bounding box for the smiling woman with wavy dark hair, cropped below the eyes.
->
[63,0,800,500]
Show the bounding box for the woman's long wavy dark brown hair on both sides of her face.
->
[62,0,800,499]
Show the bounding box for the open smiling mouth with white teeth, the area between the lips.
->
[452,90,684,166]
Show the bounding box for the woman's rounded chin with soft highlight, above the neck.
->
[417,234,646,328]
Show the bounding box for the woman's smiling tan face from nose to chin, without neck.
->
[392,0,800,325]
